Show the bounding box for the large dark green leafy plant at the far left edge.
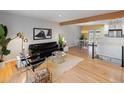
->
[0,24,11,62]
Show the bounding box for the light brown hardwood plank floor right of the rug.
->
[56,47,124,83]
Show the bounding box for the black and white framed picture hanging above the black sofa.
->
[33,28,52,40]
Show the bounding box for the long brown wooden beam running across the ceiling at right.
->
[59,10,124,25]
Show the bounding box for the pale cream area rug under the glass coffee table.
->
[52,54,83,81]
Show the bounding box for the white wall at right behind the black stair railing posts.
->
[99,24,124,59]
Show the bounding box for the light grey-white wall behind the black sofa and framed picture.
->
[0,12,80,58]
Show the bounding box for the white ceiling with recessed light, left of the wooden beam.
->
[2,10,115,22]
